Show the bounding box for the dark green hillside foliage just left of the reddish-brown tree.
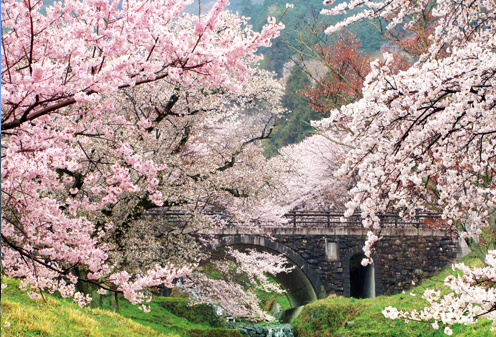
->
[264,66,321,157]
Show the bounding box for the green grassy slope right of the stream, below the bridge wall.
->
[293,256,496,337]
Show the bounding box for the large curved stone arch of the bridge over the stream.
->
[212,235,326,308]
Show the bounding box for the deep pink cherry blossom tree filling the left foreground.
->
[1,0,283,305]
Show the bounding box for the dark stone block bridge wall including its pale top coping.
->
[213,228,458,298]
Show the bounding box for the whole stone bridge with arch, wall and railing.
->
[208,211,468,308]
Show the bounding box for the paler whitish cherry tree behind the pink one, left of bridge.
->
[96,62,284,292]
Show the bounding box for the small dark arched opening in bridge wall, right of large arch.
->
[349,253,375,298]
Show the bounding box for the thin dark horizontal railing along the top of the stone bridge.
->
[285,211,441,228]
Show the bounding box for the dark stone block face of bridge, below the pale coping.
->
[275,235,456,296]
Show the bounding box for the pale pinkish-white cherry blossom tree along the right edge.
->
[319,0,496,334]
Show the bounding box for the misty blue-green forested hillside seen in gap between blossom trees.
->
[233,0,386,157]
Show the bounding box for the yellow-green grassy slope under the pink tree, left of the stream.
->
[1,277,241,337]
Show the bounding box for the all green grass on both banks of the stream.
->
[1,255,496,337]
